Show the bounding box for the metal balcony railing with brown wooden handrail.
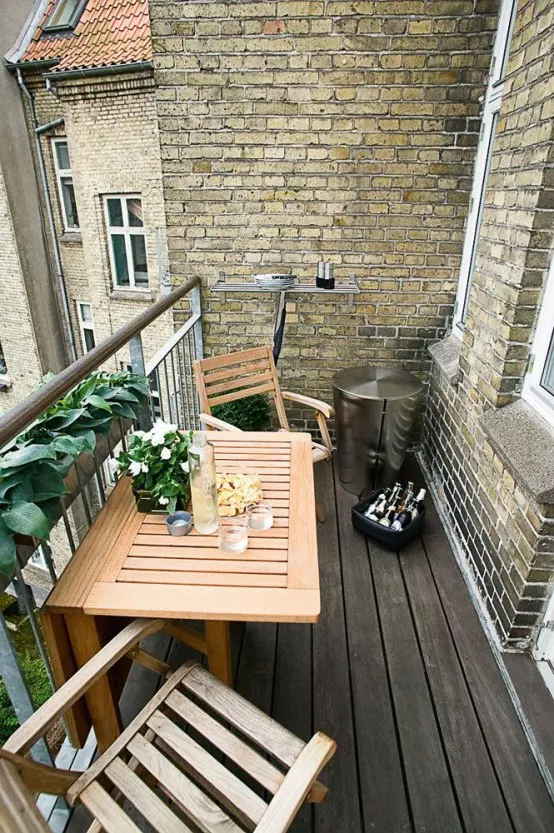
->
[0,278,203,831]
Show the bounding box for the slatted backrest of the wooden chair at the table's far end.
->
[194,346,290,431]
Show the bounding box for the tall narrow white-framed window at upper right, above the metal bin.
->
[453,0,517,338]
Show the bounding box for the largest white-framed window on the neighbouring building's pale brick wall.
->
[104,194,148,289]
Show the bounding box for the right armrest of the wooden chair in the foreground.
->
[255,732,337,833]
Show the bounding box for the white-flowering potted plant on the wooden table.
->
[118,419,192,514]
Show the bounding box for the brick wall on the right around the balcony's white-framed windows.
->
[423,0,554,647]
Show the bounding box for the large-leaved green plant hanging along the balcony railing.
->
[0,372,149,578]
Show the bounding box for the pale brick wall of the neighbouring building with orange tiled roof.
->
[23,74,174,369]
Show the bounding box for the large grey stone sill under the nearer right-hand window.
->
[480,399,554,504]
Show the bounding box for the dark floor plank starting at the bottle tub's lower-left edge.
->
[369,541,462,833]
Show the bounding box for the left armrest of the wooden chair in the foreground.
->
[3,619,164,752]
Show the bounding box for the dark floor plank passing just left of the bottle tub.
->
[335,478,411,833]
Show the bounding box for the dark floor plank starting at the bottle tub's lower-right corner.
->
[400,538,513,833]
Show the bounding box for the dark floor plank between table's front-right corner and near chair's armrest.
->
[272,623,310,833]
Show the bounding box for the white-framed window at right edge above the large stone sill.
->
[522,250,554,425]
